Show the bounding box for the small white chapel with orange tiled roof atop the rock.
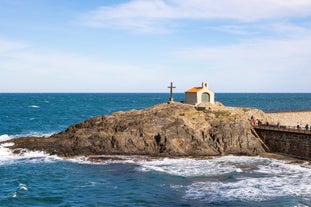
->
[185,82,215,106]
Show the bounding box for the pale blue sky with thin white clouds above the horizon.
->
[0,0,311,93]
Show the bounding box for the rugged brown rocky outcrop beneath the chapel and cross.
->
[4,103,265,157]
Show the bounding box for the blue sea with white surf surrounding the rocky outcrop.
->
[0,93,311,207]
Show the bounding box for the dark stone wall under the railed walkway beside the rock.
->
[255,128,311,159]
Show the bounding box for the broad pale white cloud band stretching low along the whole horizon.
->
[0,36,311,92]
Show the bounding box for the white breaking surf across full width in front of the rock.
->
[0,139,311,206]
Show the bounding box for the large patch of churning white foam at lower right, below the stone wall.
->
[138,156,311,203]
